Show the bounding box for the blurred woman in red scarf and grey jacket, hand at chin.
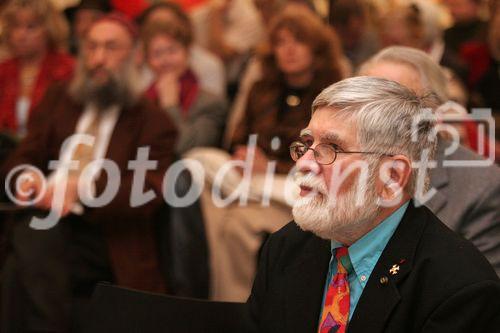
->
[142,22,227,155]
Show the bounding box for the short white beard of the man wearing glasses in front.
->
[292,171,380,241]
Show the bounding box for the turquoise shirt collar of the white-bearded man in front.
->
[331,202,409,284]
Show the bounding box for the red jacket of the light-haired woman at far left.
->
[0,52,75,131]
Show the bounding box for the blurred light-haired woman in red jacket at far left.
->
[0,0,74,136]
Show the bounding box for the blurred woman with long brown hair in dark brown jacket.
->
[232,6,342,173]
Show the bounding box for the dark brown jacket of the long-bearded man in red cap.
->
[2,85,176,291]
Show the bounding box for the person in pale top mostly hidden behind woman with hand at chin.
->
[138,1,226,97]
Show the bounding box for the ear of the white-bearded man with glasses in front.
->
[379,155,412,201]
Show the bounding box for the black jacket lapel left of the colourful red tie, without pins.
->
[284,237,331,333]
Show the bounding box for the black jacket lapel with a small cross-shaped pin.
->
[348,202,426,333]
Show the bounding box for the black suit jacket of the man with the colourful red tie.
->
[248,201,500,333]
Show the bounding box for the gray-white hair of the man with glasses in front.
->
[312,76,438,194]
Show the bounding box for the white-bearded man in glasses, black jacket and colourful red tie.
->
[247,77,500,333]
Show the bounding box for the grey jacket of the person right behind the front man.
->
[425,139,500,276]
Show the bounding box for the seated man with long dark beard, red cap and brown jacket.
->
[1,13,176,333]
